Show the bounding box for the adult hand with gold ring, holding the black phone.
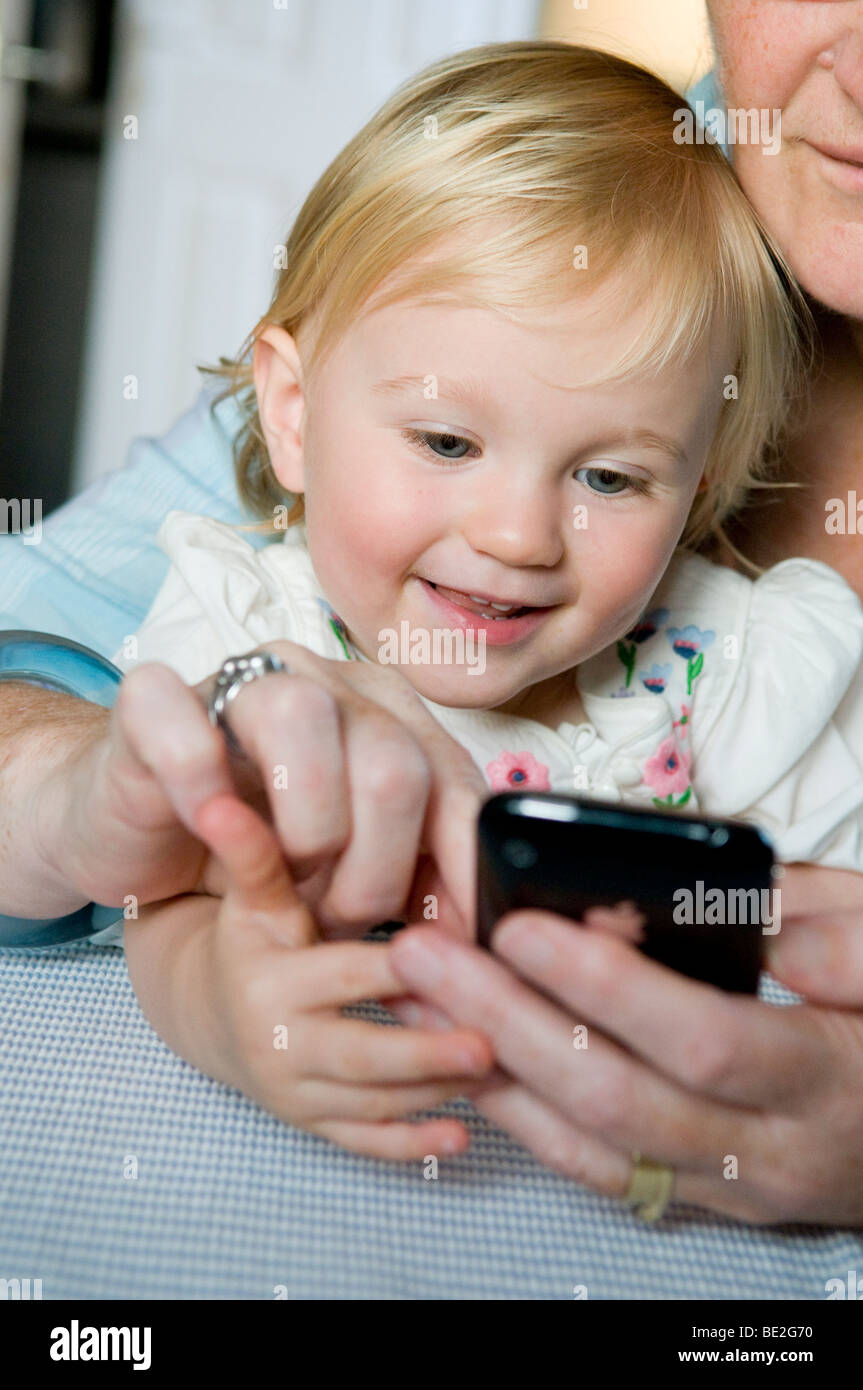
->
[391,866,863,1226]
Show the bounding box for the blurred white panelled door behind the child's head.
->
[72,0,541,489]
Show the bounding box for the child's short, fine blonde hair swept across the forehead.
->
[199,40,812,569]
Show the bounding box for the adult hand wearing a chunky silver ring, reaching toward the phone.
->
[64,641,486,935]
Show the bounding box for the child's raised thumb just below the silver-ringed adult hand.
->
[195,795,317,947]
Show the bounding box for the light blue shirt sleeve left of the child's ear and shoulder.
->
[0,378,265,657]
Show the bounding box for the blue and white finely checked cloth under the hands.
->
[0,947,863,1300]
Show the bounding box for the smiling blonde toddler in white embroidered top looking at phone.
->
[16,42,863,1158]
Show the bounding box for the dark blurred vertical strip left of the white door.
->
[0,0,114,514]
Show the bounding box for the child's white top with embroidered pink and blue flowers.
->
[114,512,863,872]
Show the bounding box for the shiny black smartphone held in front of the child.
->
[477,791,781,994]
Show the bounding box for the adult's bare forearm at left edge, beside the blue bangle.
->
[0,681,110,917]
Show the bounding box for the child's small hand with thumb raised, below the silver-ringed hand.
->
[182,795,493,1159]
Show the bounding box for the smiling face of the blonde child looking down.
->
[257,286,731,713]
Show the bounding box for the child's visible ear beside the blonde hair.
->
[252,324,306,493]
